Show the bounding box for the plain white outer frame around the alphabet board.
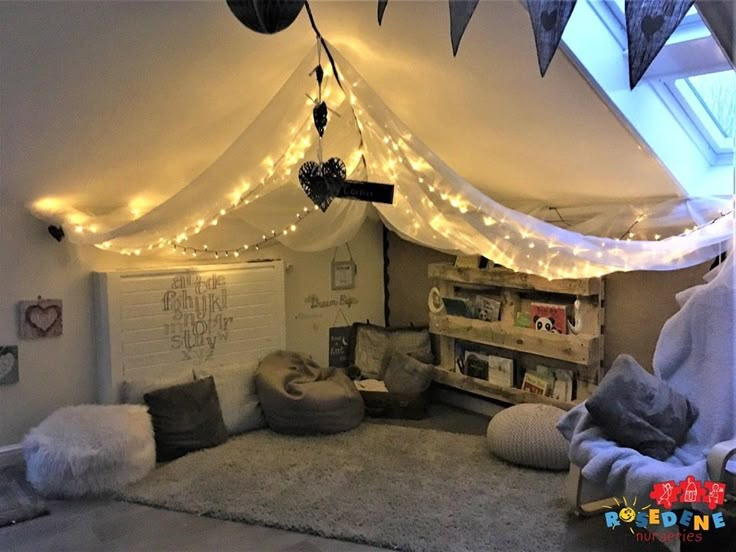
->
[92,260,286,404]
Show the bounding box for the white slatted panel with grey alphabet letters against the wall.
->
[95,261,286,402]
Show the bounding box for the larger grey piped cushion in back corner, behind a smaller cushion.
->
[351,324,433,380]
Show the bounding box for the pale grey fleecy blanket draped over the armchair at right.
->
[557,254,736,506]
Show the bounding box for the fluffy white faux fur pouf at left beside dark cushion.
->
[23,405,156,497]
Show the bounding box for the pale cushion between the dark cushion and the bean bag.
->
[194,363,266,435]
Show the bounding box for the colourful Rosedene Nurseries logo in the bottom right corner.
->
[604,475,726,542]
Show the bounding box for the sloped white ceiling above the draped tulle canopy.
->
[0,0,678,213]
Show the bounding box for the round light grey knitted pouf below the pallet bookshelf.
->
[486,403,570,470]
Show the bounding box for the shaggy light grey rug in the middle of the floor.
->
[120,424,568,552]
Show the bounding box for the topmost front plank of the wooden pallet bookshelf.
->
[428,263,601,296]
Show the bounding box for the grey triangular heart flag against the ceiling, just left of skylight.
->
[527,0,576,76]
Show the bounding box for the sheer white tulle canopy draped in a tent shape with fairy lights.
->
[28,42,734,278]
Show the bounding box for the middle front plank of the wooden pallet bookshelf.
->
[429,313,601,366]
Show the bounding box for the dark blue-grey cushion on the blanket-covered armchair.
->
[585,355,698,460]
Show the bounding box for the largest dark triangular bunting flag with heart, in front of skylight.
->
[624,0,695,90]
